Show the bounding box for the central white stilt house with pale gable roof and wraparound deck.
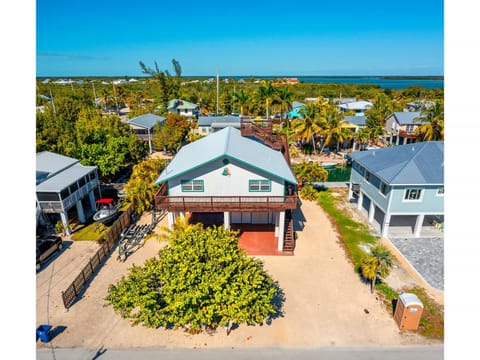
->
[155,124,297,251]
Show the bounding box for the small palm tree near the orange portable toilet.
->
[361,245,393,294]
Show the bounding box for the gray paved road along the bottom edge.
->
[37,346,444,360]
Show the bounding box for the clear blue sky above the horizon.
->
[36,0,444,76]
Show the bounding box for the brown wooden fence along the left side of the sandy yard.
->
[62,205,134,309]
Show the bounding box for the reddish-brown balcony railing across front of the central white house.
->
[155,184,297,212]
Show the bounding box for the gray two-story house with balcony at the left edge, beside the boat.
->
[36,151,100,235]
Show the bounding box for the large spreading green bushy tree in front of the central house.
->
[105,224,281,334]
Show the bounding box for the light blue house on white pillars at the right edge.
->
[349,141,444,237]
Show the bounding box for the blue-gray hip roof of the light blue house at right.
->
[350,141,444,185]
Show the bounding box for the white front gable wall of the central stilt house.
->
[168,157,285,196]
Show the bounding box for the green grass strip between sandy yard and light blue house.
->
[317,190,444,339]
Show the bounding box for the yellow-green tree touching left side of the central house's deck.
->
[125,158,166,214]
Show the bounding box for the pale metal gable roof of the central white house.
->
[155,126,297,184]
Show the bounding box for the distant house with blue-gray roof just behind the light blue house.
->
[384,111,421,145]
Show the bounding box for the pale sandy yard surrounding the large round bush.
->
[36,201,438,351]
